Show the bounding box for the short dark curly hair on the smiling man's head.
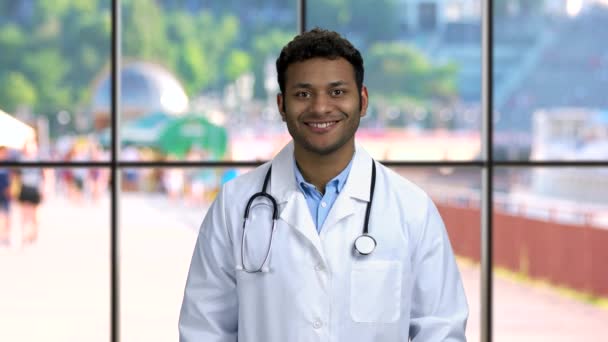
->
[276,27,364,93]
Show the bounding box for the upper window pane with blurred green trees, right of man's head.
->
[307,0,481,160]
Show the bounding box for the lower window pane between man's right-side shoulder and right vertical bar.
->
[392,166,481,342]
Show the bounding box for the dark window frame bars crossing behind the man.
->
[0,0,608,342]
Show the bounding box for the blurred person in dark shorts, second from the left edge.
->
[17,140,44,243]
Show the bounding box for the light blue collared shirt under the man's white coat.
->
[293,158,354,232]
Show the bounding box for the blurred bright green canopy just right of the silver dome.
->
[155,114,228,159]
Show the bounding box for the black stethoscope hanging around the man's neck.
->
[237,160,376,273]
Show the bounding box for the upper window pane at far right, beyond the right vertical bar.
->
[493,0,608,160]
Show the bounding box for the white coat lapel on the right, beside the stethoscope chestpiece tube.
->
[322,145,372,231]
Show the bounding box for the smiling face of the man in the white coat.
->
[277,58,368,156]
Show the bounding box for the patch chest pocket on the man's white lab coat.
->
[350,261,402,323]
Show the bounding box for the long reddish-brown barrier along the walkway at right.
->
[437,204,608,297]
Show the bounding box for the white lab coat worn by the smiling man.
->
[179,143,468,342]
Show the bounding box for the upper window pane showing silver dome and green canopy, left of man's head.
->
[117,0,297,160]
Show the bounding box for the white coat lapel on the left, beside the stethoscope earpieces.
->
[270,142,325,260]
